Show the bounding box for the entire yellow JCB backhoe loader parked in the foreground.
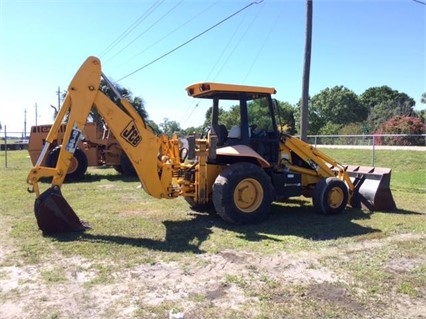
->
[27,57,396,233]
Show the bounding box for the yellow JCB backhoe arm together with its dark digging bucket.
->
[27,57,180,233]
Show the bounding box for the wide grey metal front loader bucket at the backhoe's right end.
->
[346,166,396,212]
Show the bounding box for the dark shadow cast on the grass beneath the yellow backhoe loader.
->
[50,199,418,253]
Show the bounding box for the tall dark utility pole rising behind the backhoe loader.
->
[300,0,313,142]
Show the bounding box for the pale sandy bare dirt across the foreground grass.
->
[0,237,426,318]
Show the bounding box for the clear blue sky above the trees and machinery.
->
[0,0,426,132]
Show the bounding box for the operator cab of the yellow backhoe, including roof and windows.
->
[186,82,280,164]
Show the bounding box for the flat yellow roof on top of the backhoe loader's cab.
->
[186,82,277,100]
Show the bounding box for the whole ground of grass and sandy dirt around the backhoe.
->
[0,149,426,319]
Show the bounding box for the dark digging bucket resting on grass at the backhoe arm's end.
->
[34,186,90,234]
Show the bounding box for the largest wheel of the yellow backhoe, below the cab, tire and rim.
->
[212,163,274,224]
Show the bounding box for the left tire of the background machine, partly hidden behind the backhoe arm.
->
[46,146,88,181]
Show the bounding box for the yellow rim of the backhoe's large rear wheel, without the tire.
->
[234,178,263,213]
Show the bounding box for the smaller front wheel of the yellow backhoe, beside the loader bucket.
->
[312,177,349,215]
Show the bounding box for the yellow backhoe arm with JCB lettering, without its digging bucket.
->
[27,57,178,205]
